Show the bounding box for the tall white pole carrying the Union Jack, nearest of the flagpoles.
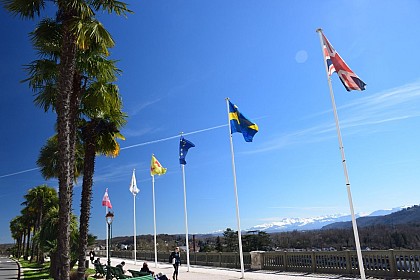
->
[316,28,366,280]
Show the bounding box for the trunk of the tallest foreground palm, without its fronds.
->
[56,17,76,280]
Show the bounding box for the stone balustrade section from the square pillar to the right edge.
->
[251,250,420,279]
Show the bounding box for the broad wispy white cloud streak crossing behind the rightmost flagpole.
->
[245,81,420,154]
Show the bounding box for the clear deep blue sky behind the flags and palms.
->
[0,0,420,243]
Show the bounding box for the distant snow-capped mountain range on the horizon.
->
[247,206,408,233]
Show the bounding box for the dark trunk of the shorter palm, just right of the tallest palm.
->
[77,123,96,280]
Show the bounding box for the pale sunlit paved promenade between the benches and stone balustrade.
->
[98,258,375,280]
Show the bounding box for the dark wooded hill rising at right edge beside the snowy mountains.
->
[322,205,420,229]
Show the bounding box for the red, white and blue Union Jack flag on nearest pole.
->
[321,32,366,91]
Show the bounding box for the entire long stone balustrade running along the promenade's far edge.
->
[97,250,420,279]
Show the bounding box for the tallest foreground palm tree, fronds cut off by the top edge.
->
[2,0,131,279]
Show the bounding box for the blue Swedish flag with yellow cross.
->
[229,101,258,142]
